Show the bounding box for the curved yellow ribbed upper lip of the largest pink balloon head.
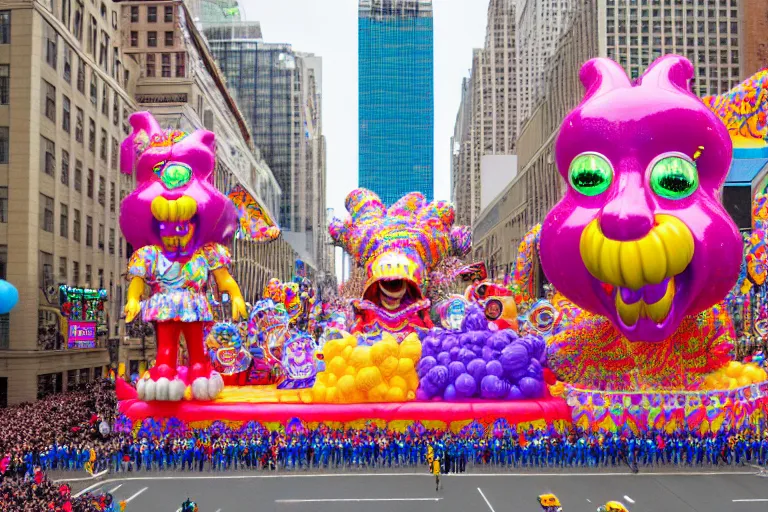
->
[579,215,694,290]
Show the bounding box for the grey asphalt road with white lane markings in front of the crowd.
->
[75,471,768,512]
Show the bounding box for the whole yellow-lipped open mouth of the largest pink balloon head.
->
[580,215,694,341]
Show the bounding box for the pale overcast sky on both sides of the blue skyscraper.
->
[240,0,488,216]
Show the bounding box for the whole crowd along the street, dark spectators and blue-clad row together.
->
[0,380,768,512]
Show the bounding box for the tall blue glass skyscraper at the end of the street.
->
[358,0,435,205]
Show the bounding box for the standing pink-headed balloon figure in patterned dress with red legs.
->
[120,112,246,401]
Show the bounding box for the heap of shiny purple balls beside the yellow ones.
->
[417,305,547,401]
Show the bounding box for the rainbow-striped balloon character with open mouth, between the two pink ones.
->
[329,188,471,334]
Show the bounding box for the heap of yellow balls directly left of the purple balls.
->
[310,333,421,404]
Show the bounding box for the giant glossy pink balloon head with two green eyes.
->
[541,55,742,342]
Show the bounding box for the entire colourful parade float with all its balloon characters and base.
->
[118,56,768,438]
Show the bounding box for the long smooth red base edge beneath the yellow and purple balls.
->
[119,397,572,424]
